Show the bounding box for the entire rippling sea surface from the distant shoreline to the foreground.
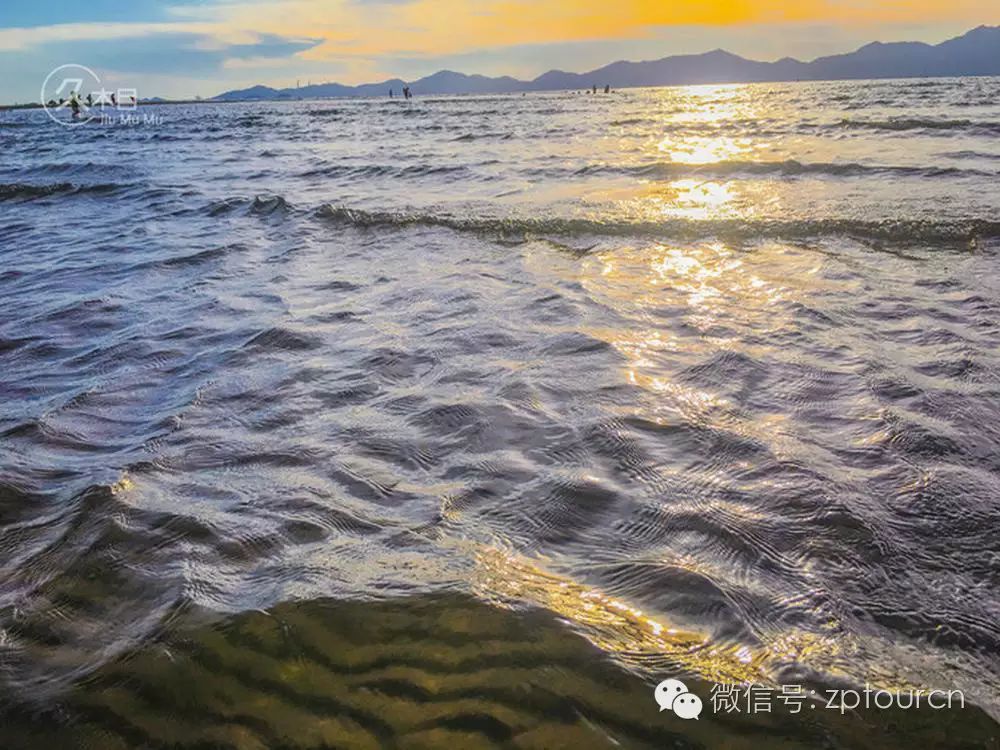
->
[0,79,1000,748]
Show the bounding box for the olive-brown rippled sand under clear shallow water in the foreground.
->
[0,596,1000,750]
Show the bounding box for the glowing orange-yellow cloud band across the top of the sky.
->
[176,0,1000,66]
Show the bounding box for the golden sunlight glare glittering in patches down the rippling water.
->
[492,84,936,688]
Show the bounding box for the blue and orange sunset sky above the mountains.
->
[0,0,1000,103]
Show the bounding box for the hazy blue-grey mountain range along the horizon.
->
[216,26,1000,100]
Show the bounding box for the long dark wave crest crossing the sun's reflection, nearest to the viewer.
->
[315,205,1000,247]
